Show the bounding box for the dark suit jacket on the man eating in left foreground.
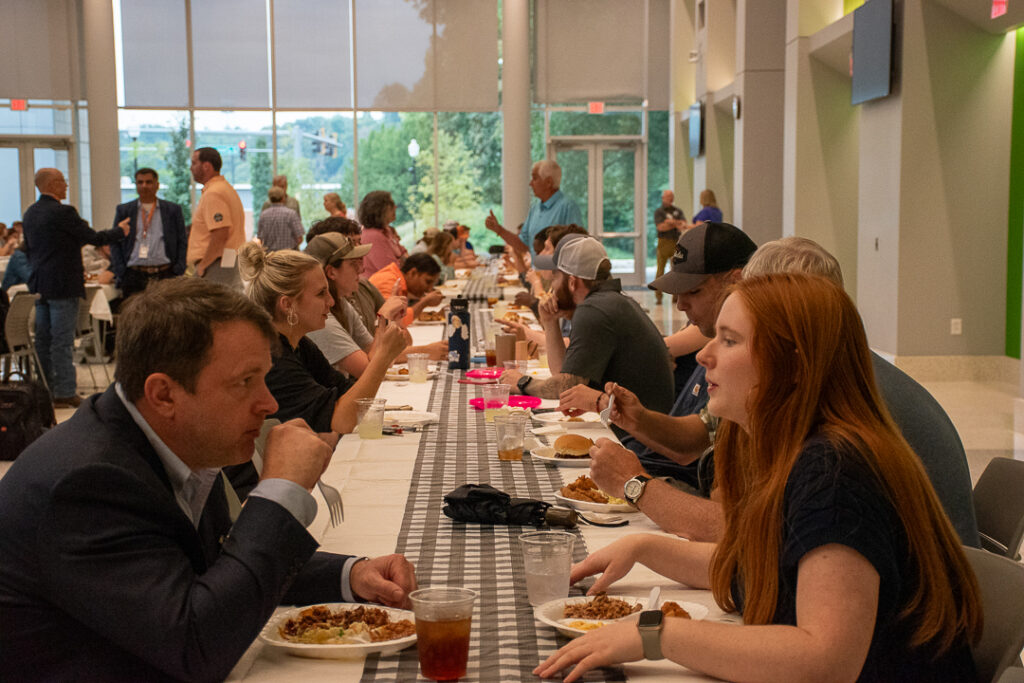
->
[0,387,346,681]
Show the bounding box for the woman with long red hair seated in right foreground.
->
[535,274,982,682]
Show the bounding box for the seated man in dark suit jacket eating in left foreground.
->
[0,278,416,681]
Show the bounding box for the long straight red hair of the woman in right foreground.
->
[711,273,982,652]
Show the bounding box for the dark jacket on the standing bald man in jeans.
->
[22,195,124,299]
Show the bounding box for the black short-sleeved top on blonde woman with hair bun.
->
[266,335,352,432]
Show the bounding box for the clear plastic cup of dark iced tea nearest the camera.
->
[409,587,479,681]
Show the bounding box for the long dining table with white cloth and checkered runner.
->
[228,280,738,683]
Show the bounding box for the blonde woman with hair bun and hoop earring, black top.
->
[239,242,406,434]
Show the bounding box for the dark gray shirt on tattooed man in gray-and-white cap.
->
[562,280,675,438]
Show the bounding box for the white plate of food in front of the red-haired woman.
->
[534,593,708,638]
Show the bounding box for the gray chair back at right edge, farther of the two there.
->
[974,458,1024,560]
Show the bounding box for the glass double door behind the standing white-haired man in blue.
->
[551,138,646,286]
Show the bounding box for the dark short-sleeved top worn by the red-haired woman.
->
[732,436,977,683]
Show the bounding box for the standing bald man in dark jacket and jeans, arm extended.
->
[23,168,129,408]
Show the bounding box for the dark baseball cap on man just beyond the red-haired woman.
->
[647,222,758,294]
